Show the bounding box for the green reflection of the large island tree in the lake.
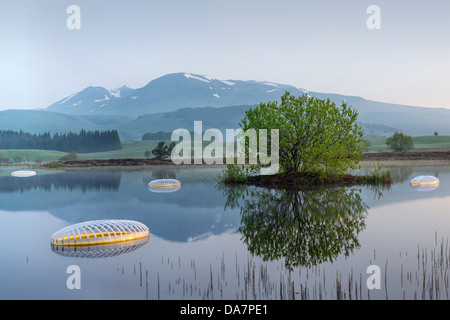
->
[219,186,368,268]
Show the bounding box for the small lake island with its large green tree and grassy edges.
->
[217,92,392,189]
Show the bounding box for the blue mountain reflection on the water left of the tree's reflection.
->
[0,168,240,242]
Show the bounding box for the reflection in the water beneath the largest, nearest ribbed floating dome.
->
[52,237,148,258]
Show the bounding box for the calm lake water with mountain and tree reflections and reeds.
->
[0,167,450,300]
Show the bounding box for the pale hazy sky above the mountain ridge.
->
[0,0,450,109]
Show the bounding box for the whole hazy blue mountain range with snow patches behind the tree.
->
[0,73,450,140]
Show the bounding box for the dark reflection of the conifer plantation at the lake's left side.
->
[0,171,121,193]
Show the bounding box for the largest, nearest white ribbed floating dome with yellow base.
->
[51,220,149,246]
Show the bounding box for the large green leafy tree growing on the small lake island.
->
[241,92,367,175]
